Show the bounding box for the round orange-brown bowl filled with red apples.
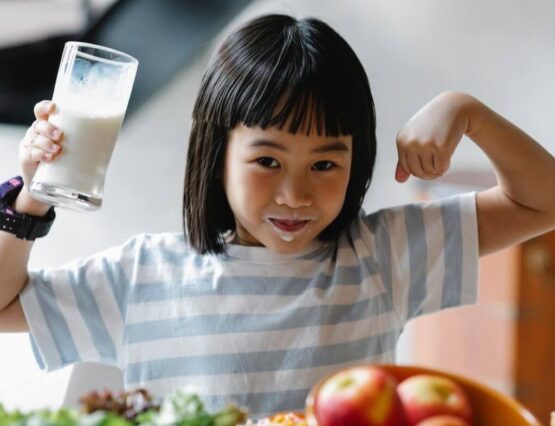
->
[306,364,542,426]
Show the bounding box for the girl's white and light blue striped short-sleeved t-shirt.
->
[21,193,478,417]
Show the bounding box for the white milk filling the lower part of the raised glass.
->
[33,104,124,199]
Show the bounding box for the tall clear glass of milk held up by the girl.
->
[30,41,138,211]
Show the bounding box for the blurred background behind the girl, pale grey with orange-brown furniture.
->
[0,0,555,422]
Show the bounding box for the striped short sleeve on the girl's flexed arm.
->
[362,192,479,324]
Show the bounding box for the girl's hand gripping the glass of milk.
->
[19,101,63,187]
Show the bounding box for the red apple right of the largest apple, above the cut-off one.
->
[397,374,472,426]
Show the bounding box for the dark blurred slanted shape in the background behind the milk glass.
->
[0,0,250,124]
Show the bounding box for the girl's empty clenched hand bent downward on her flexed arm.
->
[395,92,474,182]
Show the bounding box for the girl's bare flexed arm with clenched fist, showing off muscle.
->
[395,92,555,255]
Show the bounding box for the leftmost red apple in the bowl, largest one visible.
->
[309,366,406,426]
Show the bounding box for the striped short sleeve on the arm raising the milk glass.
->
[20,235,141,371]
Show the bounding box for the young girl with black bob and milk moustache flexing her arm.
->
[0,15,555,417]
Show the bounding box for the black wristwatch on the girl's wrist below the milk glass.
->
[0,176,56,241]
